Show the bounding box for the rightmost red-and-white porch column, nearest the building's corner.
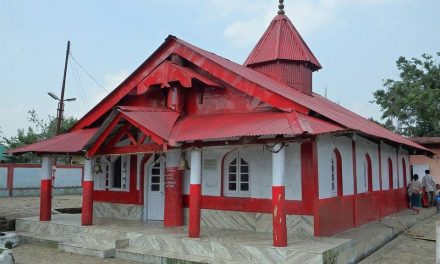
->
[272,143,287,247]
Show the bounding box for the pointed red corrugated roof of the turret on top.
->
[244,15,322,70]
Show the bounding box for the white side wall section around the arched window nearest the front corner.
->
[317,135,354,199]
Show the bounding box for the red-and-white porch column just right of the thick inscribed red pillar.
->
[188,149,202,238]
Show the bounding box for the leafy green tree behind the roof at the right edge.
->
[374,52,440,137]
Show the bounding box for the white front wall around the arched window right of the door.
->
[183,143,302,200]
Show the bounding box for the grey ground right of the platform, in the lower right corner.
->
[361,212,440,264]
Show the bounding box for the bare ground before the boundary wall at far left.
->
[0,195,82,219]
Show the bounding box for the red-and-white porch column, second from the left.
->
[81,158,93,226]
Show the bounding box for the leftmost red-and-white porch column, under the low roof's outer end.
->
[40,157,55,221]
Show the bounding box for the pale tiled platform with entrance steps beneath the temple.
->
[16,209,436,264]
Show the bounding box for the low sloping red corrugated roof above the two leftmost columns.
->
[8,128,98,154]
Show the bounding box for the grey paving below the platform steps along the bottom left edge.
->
[12,244,138,264]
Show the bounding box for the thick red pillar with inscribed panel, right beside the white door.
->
[163,151,184,227]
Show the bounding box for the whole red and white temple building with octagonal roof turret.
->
[10,1,429,247]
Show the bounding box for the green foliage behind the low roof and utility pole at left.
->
[2,109,77,163]
